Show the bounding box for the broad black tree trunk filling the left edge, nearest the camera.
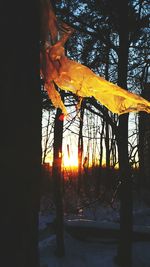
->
[0,1,41,267]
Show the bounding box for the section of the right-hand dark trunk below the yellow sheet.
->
[118,114,132,266]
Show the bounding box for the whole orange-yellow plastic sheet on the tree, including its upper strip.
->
[41,0,150,115]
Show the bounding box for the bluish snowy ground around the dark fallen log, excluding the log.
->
[39,195,150,267]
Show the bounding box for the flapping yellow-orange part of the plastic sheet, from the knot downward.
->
[41,42,150,115]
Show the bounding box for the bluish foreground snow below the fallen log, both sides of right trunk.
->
[40,231,150,267]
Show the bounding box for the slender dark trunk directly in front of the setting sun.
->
[53,109,65,257]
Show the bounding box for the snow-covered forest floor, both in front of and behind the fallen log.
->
[39,193,150,267]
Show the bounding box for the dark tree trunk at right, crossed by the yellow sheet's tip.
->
[118,0,132,267]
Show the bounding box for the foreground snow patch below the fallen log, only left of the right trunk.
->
[40,234,118,267]
